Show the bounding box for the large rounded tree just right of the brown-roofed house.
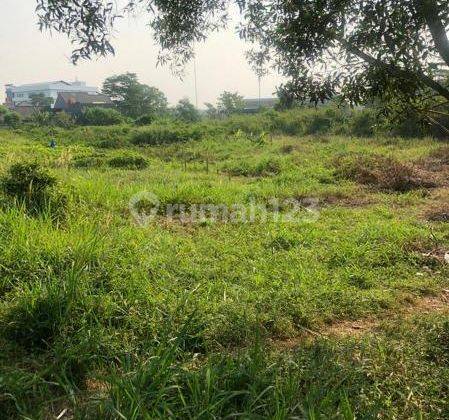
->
[102,73,167,118]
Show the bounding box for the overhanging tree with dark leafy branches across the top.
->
[34,0,449,123]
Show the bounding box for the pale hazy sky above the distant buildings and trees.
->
[0,0,281,107]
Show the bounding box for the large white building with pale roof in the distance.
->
[5,80,98,110]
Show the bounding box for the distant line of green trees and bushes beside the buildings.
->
[0,72,256,128]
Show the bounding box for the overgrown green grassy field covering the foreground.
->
[0,115,449,419]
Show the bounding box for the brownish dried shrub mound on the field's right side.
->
[335,155,435,192]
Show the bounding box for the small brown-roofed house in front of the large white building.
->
[53,92,114,115]
